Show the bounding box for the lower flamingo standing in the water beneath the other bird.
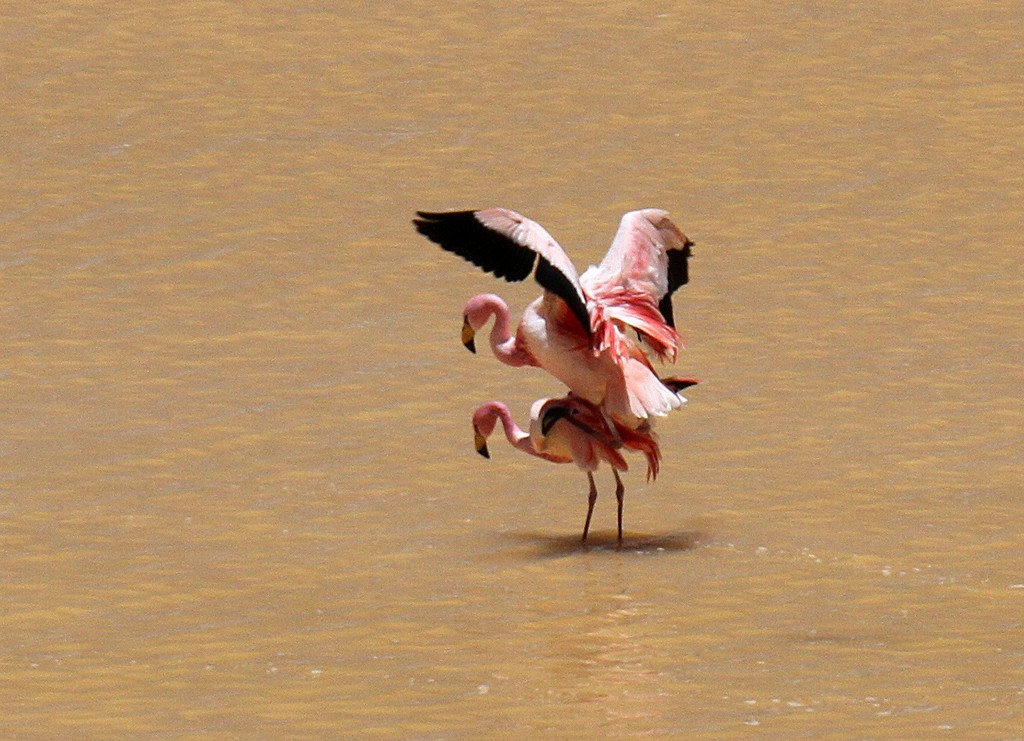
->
[473,386,696,543]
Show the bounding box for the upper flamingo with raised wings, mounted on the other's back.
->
[414,208,693,429]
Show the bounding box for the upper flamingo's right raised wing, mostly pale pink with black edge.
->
[598,209,693,326]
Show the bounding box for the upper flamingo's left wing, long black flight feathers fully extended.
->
[413,208,591,337]
